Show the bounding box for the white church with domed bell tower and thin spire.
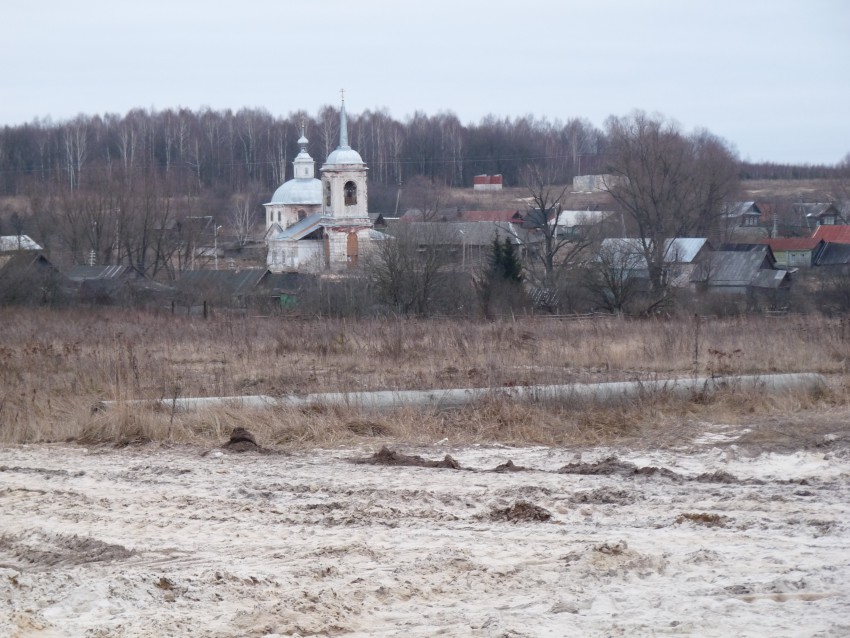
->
[264,100,383,272]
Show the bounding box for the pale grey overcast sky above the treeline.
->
[0,0,850,164]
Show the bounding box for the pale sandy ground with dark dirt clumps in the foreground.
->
[0,428,850,638]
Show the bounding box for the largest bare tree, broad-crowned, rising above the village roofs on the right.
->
[606,112,739,293]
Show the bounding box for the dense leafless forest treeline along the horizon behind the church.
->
[0,106,838,207]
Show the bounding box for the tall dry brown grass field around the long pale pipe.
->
[0,308,850,446]
